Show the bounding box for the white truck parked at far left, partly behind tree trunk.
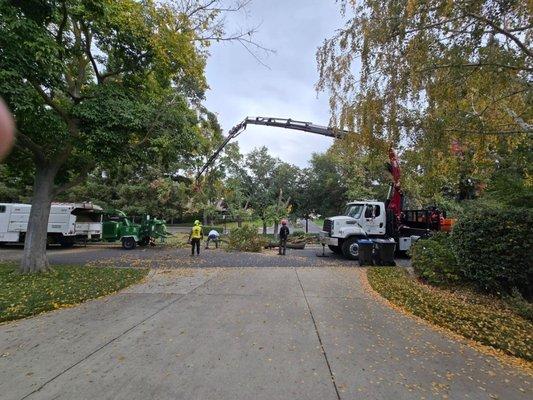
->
[0,203,102,247]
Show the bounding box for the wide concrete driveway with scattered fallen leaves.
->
[0,251,532,400]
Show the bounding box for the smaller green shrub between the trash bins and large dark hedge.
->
[411,232,461,286]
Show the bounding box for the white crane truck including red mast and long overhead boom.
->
[196,117,450,259]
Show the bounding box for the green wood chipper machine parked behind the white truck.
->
[102,210,171,250]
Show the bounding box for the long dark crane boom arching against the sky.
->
[196,117,349,180]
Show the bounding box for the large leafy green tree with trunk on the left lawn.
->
[0,0,206,272]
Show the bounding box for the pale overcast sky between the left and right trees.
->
[205,0,342,167]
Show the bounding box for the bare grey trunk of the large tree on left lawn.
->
[20,164,57,273]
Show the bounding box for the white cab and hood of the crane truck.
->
[320,200,387,260]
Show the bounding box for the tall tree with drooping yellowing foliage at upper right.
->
[317,0,533,203]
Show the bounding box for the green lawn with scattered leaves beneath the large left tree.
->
[0,264,148,322]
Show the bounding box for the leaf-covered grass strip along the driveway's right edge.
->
[368,267,533,361]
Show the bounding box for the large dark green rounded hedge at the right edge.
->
[451,206,533,300]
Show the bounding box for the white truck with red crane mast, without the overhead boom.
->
[320,149,453,260]
